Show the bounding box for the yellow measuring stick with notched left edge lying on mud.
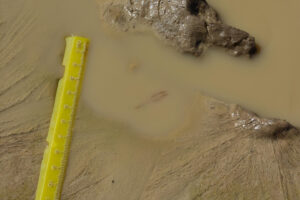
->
[35,36,89,200]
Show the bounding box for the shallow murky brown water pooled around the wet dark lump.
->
[33,0,300,138]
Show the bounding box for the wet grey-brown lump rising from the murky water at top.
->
[104,0,256,56]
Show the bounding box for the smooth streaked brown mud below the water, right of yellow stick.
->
[63,94,300,200]
